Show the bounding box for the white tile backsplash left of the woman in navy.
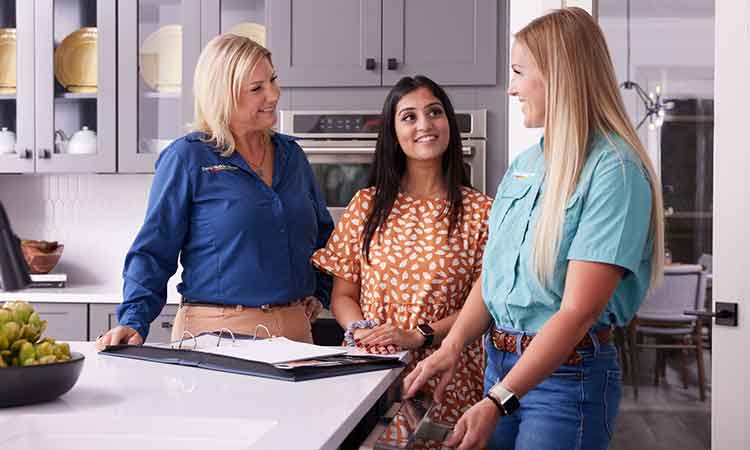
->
[0,174,182,291]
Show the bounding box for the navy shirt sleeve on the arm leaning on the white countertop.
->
[117,148,191,339]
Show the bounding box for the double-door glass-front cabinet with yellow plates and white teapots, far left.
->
[0,0,117,173]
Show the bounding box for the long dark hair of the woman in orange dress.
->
[362,75,471,263]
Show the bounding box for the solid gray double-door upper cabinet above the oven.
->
[267,0,498,87]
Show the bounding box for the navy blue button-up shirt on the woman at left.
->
[117,133,333,338]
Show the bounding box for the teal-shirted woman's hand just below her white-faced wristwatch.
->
[443,398,500,450]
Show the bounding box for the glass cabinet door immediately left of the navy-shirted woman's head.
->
[117,0,201,173]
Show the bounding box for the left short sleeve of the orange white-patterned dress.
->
[312,190,371,283]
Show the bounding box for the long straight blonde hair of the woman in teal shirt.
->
[515,7,664,287]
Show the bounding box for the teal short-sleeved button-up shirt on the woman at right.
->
[482,132,653,332]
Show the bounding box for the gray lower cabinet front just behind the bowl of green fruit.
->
[32,303,88,341]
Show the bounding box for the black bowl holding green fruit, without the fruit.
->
[0,352,84,407]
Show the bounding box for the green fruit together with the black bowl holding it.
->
[0,301,84,408]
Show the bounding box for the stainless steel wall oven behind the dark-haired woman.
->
[279,110,487,220]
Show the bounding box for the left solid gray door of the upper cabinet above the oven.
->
[266,0,381,87]
